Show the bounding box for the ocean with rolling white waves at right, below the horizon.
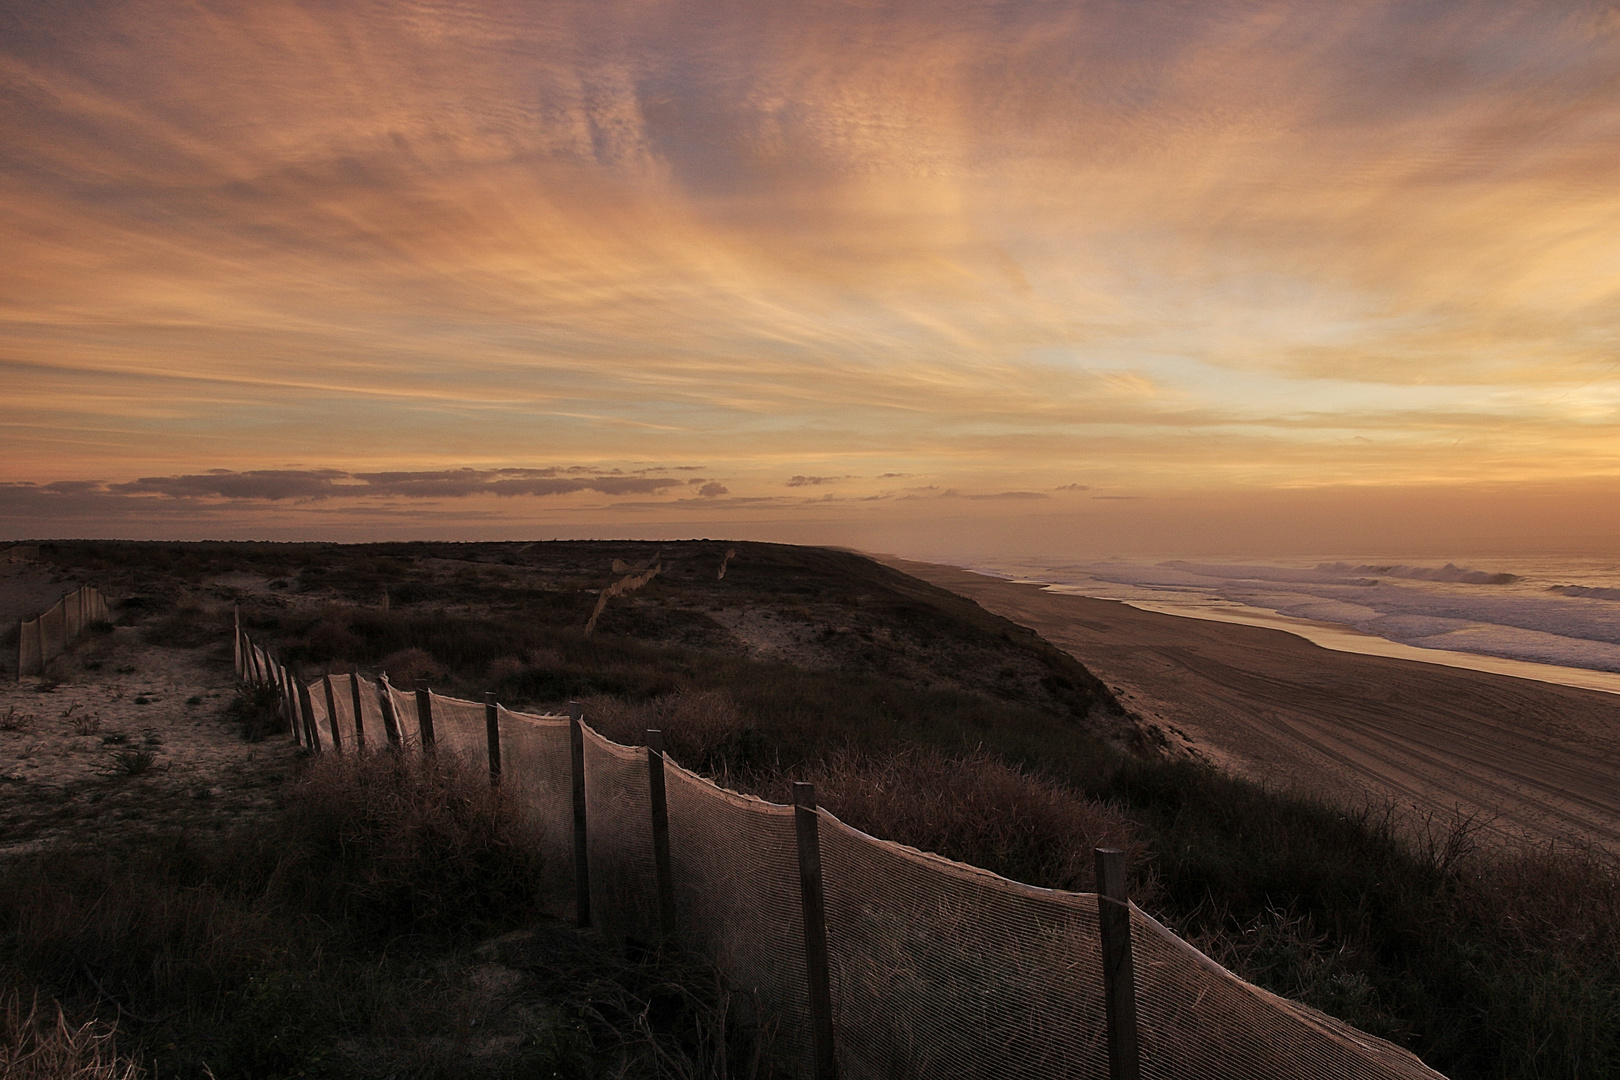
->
[962,555,1620,693]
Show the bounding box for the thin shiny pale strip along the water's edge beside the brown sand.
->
[1023,586,1620,695]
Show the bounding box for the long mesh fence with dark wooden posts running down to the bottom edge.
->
[237,623,1443,1080]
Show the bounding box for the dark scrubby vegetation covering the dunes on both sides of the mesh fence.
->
[0,541,1620,1080]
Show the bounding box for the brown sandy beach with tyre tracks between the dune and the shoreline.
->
[883,557,1620,852]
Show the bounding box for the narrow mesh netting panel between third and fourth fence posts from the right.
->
[585,727,658,942]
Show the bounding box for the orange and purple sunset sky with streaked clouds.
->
[0,0,1620,557]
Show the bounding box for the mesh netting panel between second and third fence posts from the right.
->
[660,764,813,1075]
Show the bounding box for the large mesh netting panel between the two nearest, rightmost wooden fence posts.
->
[821,811,1108,1080]
